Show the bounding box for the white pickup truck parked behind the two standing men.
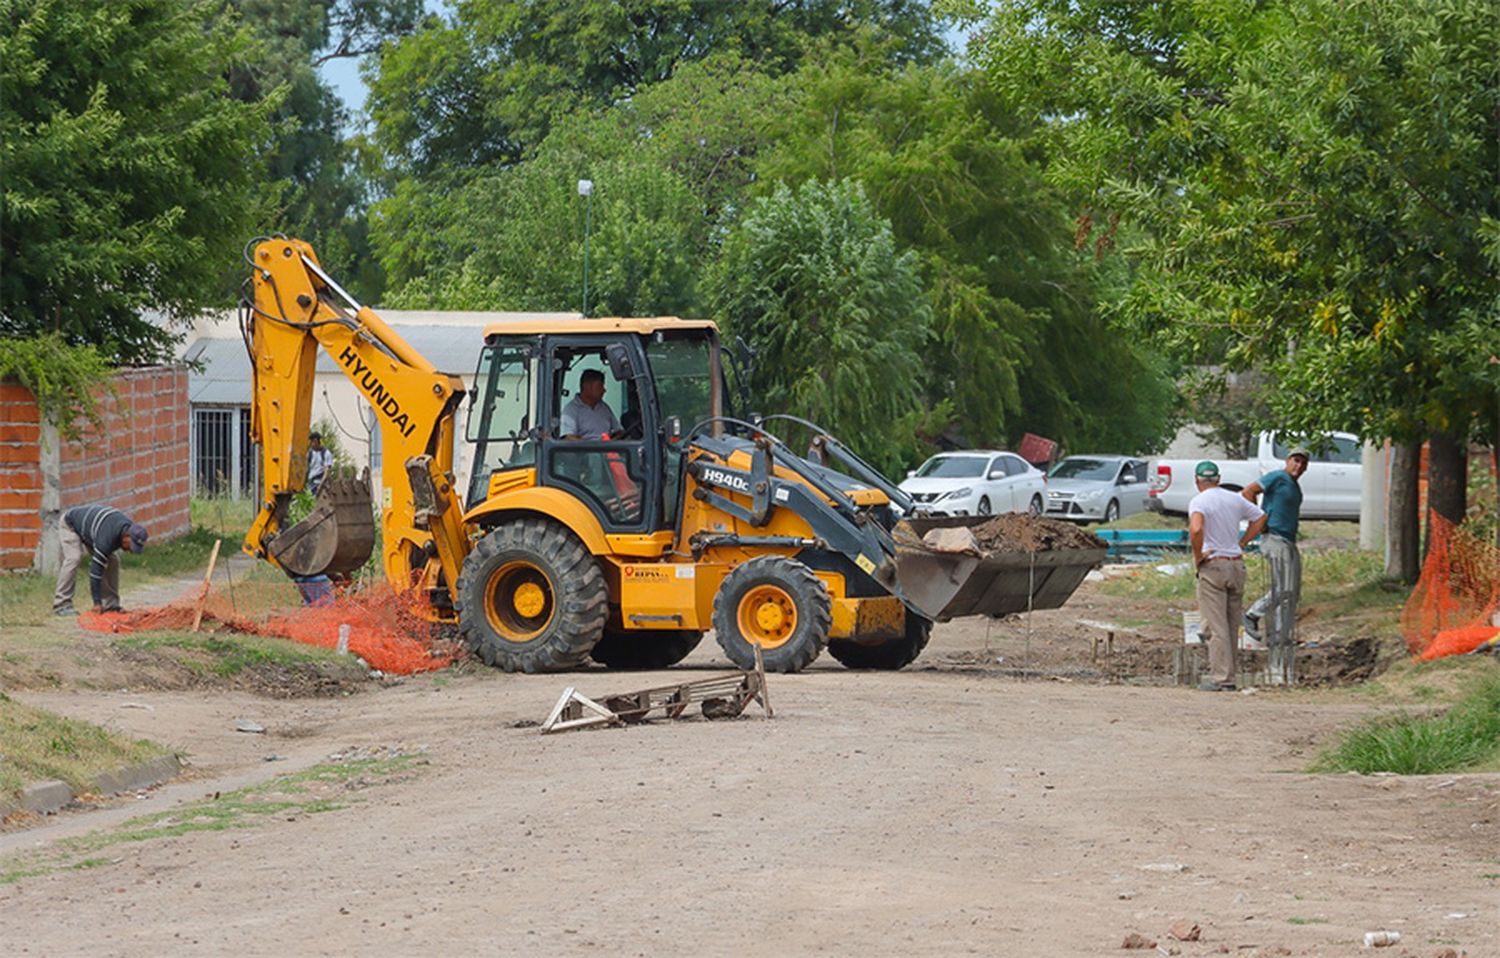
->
[1146,432,1362,519]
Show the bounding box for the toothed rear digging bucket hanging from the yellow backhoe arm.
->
[267,469,375,576]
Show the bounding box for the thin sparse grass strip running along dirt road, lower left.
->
[0,753,428,885]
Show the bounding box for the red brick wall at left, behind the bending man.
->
[0,366,191,568]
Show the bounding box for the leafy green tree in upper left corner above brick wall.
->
[0,0,276,363]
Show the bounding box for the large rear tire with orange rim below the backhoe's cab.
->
[455,519,609,672]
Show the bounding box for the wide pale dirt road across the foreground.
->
[0,627,1500,958]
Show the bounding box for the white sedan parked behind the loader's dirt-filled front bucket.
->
[902,450,1047,516]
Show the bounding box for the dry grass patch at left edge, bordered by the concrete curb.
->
[0,694,168,801]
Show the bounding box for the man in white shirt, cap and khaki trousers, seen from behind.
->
[1188,460,1266,691]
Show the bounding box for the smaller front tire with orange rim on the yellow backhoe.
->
[714,556,834,672]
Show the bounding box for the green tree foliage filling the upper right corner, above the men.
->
[977,0,1500,439]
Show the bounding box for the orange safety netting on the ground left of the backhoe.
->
[78,579,459,675]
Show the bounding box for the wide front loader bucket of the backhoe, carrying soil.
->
[896,517,1109,622]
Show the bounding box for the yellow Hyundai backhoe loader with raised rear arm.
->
[242,238,1103,672]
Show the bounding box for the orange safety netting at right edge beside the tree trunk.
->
[1401,513,1500,660]
